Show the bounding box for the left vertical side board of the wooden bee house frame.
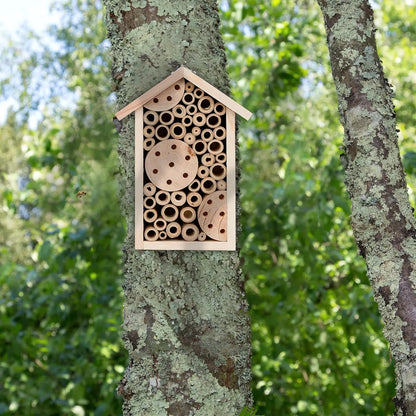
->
[134,107,145,250]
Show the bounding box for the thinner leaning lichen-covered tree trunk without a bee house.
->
[318,0,416,415]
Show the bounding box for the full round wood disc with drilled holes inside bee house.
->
[145,139,198,191]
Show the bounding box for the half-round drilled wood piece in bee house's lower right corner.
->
[198,191,227,241]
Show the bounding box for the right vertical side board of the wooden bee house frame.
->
[226,108,237,250]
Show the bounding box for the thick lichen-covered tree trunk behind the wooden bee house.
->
[104,0,251,416]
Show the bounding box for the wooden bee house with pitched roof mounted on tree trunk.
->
[116,67,251,250]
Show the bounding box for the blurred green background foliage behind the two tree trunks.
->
[0,0,416,416]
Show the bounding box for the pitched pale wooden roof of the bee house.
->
[116,66,252,120]
